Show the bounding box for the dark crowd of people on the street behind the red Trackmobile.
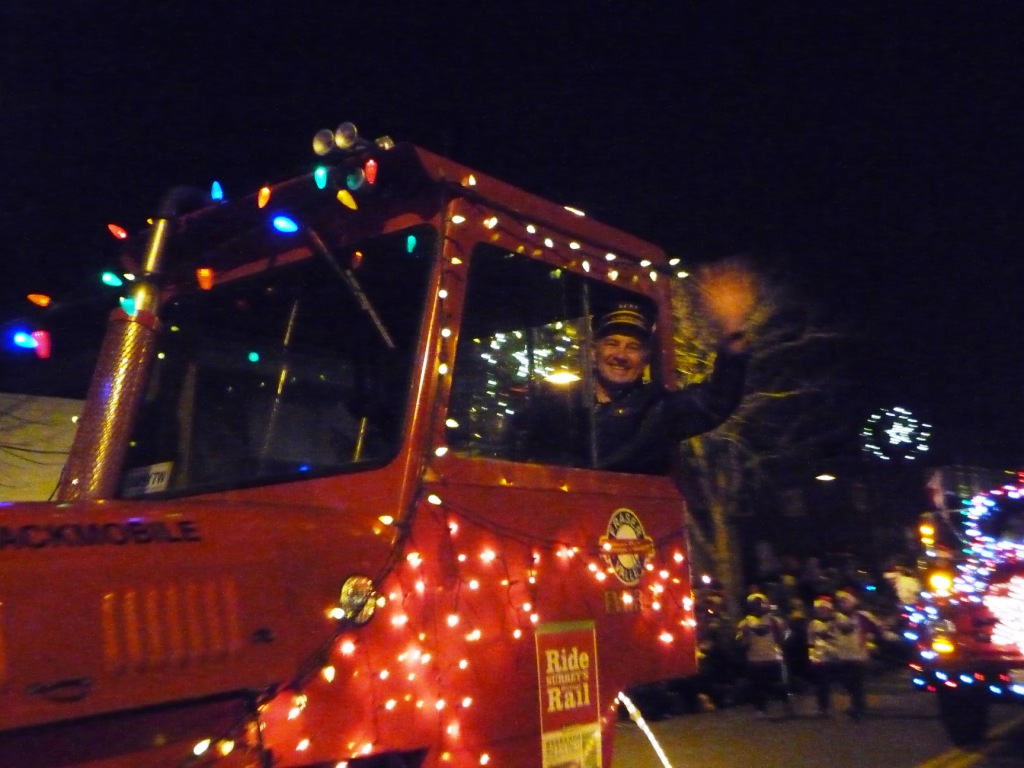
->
[697,558,921,720]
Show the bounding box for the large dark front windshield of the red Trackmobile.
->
[122,227,434,498]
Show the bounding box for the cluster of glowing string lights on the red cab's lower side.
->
[229,495,689,764]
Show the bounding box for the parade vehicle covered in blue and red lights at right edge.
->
[911,473,1024,743]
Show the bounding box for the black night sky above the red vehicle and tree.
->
[0,0,1024,468]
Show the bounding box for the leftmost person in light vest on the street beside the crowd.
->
[736,592,794,718]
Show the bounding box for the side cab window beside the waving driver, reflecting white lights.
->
[446,245,648,467]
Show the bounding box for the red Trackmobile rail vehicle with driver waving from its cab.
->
[0,124,695,768]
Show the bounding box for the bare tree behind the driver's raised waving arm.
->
[673,268,848,604]
